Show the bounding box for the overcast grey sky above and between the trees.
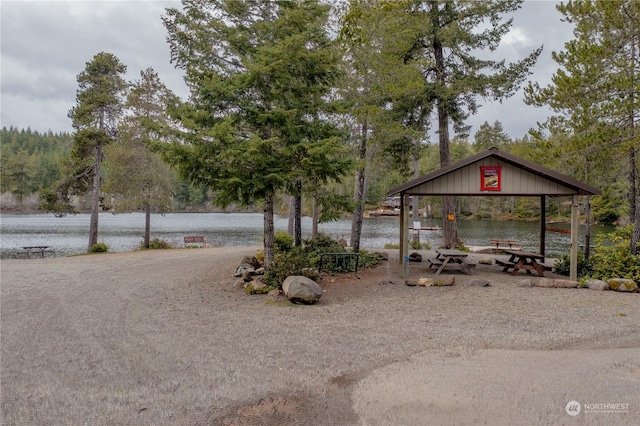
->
[0,0,572,138]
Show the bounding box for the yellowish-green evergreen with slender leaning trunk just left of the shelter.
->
[339,0,431,251]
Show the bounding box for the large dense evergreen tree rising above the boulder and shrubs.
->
[164,0,348,267]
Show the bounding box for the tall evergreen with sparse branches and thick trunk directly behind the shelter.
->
[407,0,542,248]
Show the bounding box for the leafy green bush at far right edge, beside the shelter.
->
[591,226,640,282]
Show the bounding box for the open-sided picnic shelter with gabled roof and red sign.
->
[387,148,601,280]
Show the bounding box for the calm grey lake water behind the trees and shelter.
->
[0,213,613,258]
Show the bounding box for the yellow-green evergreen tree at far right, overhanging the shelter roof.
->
[526,0,640,254]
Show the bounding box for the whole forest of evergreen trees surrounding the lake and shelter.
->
[1,0,640,263]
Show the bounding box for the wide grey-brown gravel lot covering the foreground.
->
[0,247,640,426]
